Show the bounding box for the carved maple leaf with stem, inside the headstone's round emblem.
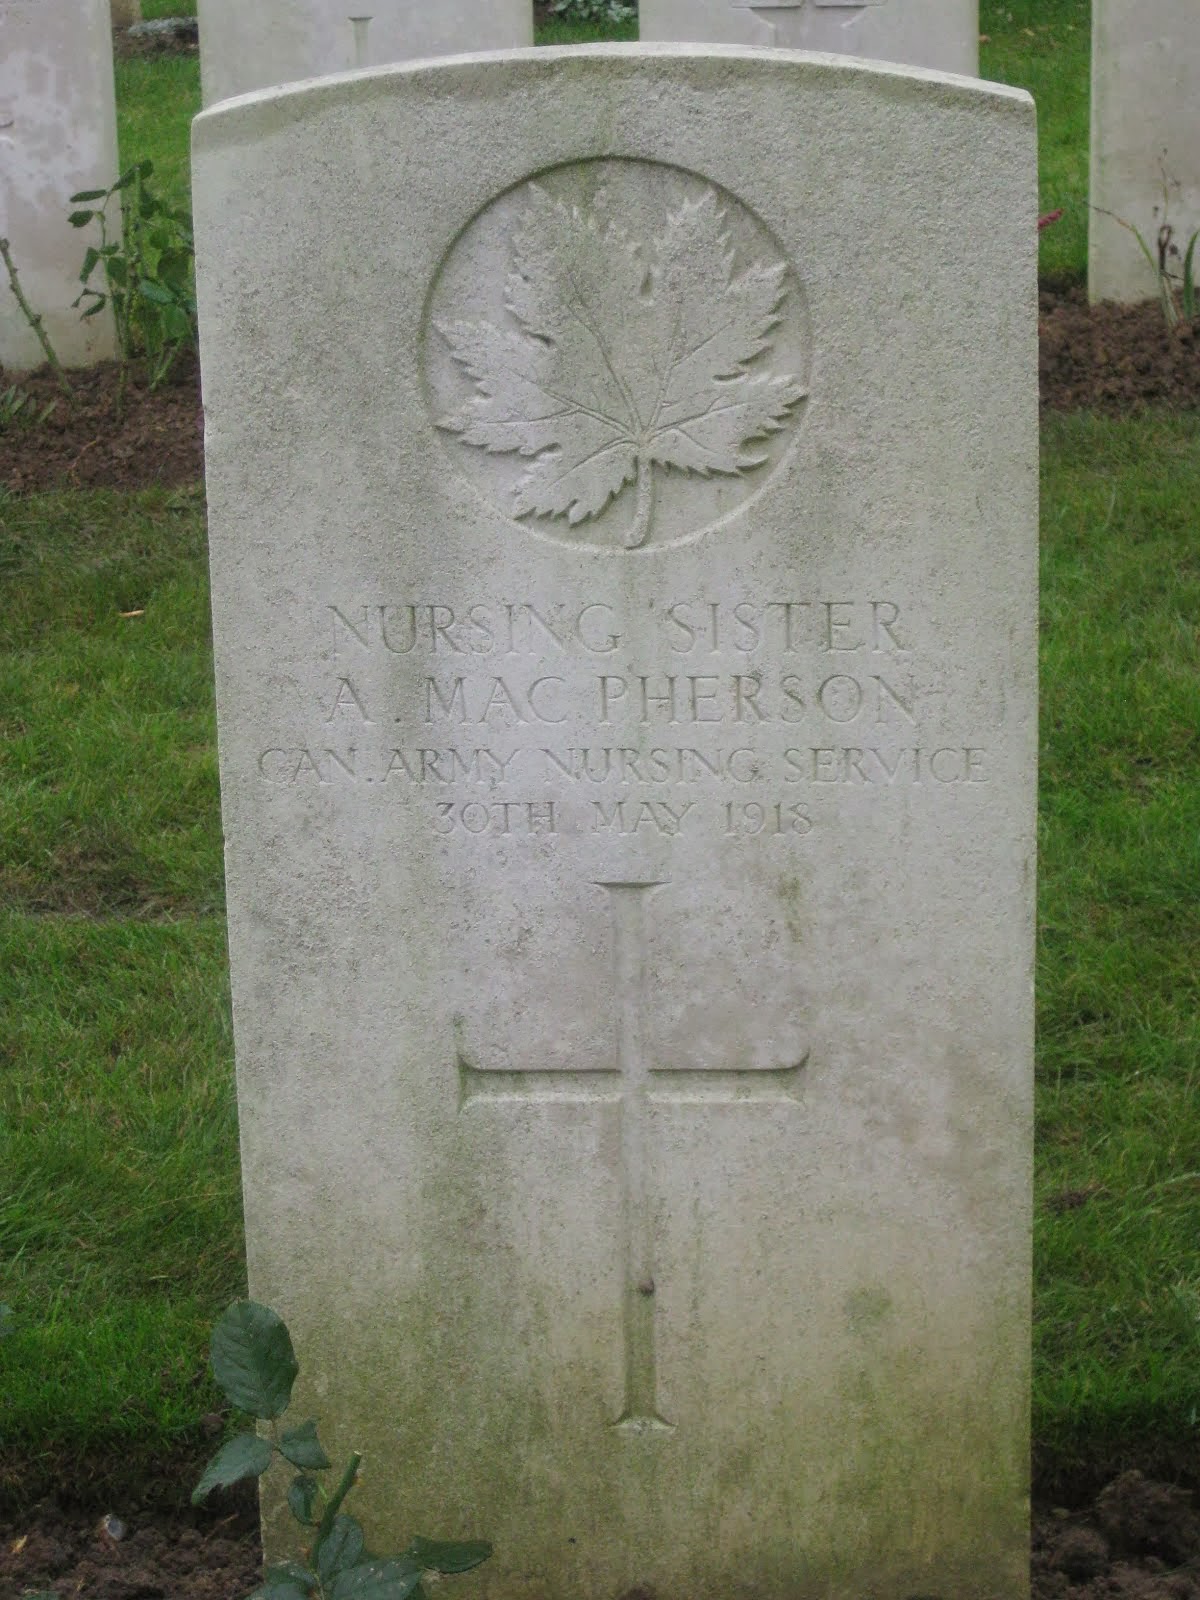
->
[437,184,806,549]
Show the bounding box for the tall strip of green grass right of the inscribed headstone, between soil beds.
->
[1035,416,1200,1472]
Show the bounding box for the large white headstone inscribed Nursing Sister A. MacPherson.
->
[194,46,1037,1600]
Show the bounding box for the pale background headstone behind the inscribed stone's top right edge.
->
[638,0,979,77]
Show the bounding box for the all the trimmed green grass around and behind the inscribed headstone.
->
[0,0,1200,1504]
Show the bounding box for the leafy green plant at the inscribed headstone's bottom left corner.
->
[192,1301,491,1600]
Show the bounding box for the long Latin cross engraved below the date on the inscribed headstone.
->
[458,880,808,1434]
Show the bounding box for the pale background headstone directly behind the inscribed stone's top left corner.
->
[198,0,533,106]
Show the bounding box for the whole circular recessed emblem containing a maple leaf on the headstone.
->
[424,160,811,550]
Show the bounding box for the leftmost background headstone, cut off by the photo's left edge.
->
[0,0,120,371]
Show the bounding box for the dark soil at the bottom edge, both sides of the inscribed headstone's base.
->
[0,1472,1200,1600]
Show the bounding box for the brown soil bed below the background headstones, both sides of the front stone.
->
[0,288,1200,493]
